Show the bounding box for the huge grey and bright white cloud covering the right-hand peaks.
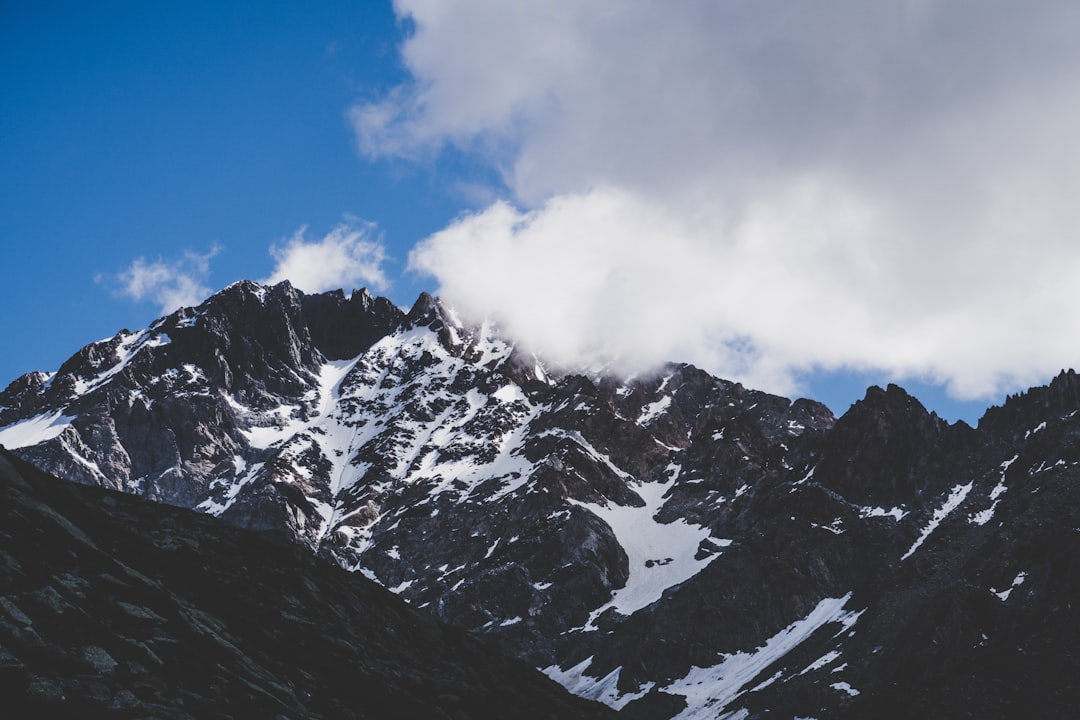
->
[358,0,1080,398]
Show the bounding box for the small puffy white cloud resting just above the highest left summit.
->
[261,218,389,293]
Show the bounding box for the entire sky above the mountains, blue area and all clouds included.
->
[0,0,1080,422]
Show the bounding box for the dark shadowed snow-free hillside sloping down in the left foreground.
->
[0,450,615,720]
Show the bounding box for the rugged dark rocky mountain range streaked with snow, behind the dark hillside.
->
[0,283,1080,719]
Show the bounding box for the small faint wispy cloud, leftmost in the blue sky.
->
[110,247,219,314]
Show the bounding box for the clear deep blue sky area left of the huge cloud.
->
[0,2,477,371]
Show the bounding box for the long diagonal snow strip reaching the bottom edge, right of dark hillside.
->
[661,593,862,720]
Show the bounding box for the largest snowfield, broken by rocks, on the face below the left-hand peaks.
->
[211,327,544,556]
